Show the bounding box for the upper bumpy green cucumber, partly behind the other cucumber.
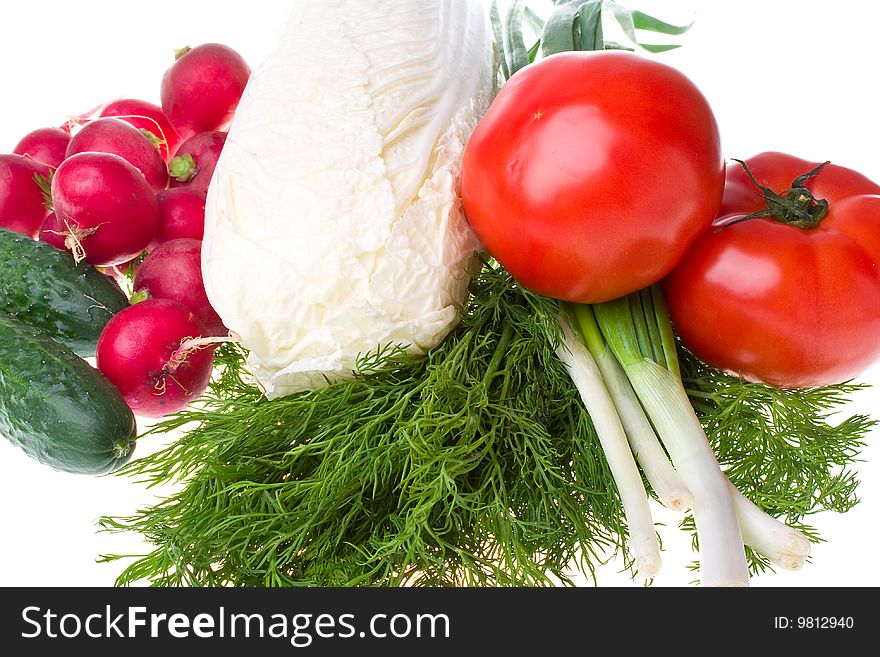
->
[0,229,128,358]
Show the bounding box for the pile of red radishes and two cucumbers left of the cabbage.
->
[0,44,250,466]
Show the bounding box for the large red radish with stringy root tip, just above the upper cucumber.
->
[52,153,159,267]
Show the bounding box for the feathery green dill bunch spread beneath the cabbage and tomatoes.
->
[102,266,871,586]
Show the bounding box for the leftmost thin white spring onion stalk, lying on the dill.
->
[556,315,660,579]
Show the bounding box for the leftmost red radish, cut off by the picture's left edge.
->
[0,155,49,237]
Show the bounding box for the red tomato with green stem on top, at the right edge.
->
[665,153,880,388]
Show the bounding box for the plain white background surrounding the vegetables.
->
[0,0,880,586]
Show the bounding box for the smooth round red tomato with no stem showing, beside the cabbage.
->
[461,51,724,303]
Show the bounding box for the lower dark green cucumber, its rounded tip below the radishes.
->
[0,311,137,474]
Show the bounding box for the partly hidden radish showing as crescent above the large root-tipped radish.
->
[67,119,168,192]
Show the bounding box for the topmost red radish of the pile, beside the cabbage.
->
[161,43,251,139]
